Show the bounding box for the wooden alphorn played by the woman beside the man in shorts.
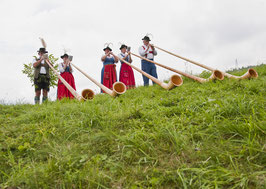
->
[71,63,127,97]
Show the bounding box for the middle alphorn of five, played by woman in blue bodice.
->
[118,57,183,90]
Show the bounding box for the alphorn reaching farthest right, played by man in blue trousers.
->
[152,45,258,79]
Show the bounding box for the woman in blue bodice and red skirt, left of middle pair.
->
[101,47,117,93]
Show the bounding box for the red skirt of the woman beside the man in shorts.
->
[57,72,76,100]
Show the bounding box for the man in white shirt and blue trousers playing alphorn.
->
[139,36,158,86]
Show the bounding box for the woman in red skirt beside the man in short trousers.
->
[57,54,76,100]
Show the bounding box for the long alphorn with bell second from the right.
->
[131,53,220,83]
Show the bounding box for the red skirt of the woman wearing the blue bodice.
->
[102,64,116,93]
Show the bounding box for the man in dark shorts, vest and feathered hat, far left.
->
[32,48,50,104]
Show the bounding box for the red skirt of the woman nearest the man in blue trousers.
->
[119,64,135,89]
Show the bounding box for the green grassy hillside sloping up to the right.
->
[0,65,266,188]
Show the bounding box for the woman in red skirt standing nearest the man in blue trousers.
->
[118,45,135,89]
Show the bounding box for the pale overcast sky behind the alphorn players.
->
[0,0,266,103]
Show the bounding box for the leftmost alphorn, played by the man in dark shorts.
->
[44,54,94,101]
